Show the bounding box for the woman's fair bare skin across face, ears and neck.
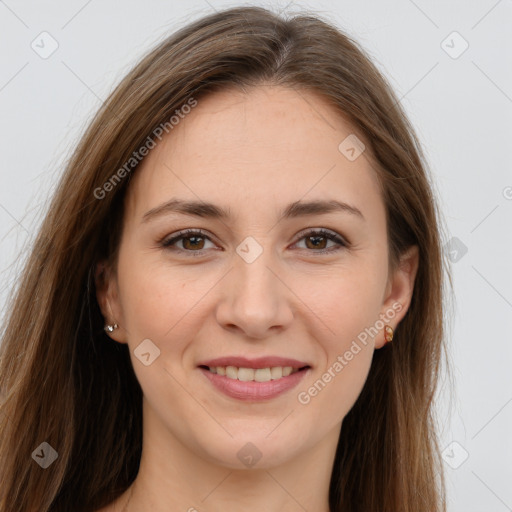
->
[97,86,418,512]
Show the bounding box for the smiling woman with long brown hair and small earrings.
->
[0,7,445,512]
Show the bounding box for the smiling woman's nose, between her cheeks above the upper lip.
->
[216,250,293,339]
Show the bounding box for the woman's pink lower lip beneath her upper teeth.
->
[199,368,311,402]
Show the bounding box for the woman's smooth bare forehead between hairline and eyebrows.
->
[124,86,382,224]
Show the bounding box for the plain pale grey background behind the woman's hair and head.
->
[0,0,512,512]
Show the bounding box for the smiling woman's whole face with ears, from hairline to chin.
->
[98,86,417,468]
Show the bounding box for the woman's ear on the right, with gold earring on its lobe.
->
[375,245,419,349]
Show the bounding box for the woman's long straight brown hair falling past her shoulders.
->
[0,7,451,512]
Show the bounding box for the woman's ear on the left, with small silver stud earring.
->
[94,261,127,343]
